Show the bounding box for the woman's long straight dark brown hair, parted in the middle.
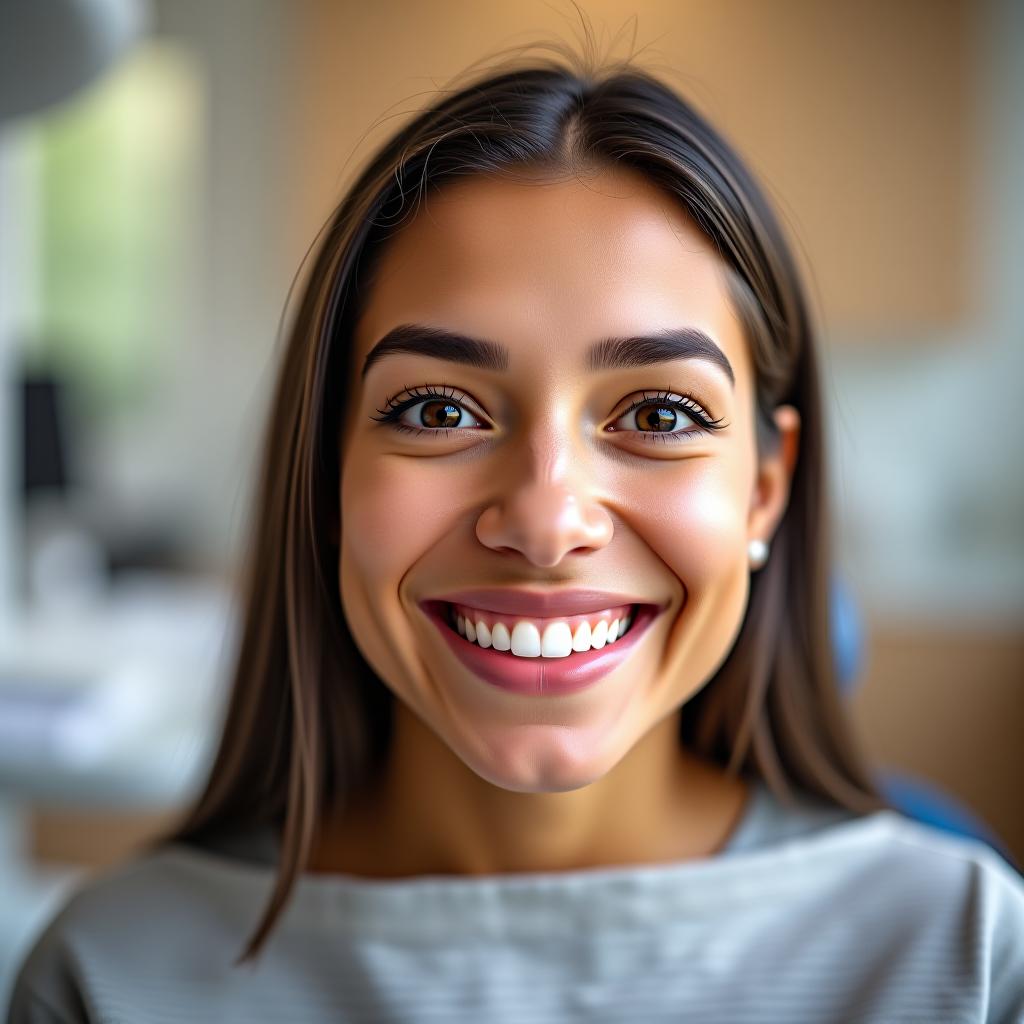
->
[158,41,889,963]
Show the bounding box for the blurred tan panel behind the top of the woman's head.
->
[285,0,985,333]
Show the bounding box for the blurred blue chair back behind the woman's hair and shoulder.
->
[829,577,1024,873]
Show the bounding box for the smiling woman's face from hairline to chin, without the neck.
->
[339,170,798,792]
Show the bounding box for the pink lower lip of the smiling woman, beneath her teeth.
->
[425,601,660,696]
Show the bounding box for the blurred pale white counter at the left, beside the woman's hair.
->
[0,574,234,811]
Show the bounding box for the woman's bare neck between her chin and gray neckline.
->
[309,701,749,878]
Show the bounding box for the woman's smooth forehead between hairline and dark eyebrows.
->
[353,169,751,390]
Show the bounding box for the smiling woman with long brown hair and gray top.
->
[11,49,1024,1024]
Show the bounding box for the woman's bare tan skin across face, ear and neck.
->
[310,169,799,877]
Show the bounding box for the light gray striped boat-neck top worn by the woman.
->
[7,783,1024,1024]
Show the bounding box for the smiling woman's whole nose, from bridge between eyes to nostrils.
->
[477,402,611,566]
